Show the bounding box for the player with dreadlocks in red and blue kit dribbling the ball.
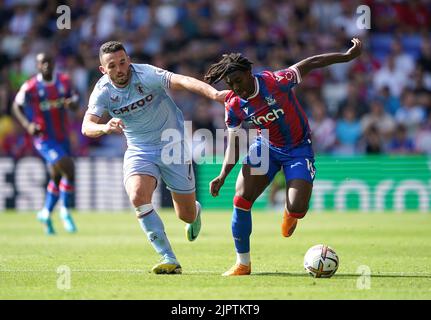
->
[205,38,361,276]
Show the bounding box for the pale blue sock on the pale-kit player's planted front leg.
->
[136,205,176,260]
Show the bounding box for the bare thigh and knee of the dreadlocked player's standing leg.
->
[235,164,271,202]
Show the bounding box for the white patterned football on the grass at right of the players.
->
[304,244,339,278]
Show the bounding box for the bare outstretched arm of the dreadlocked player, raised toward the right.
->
[294,38,362,77]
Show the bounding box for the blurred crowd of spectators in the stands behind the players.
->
[0,0,431,157]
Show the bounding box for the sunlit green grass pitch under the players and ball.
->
[0,210,431,300]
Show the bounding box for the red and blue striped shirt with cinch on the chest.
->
[225,66,310,149]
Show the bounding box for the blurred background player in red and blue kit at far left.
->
[12,53,78,234]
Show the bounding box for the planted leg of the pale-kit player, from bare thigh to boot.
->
[125,174,181,274]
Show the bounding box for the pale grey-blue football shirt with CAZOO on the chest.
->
[87,64,184,150]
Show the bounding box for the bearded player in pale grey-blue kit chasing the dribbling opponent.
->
[82,41,227,274]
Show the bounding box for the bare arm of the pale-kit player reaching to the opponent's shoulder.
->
[170,73,229,103]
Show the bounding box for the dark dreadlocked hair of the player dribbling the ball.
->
[205,53,253,84]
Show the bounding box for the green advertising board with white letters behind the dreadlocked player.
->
[196,156,431,212]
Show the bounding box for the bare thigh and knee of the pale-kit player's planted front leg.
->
[124,174,157,207]
